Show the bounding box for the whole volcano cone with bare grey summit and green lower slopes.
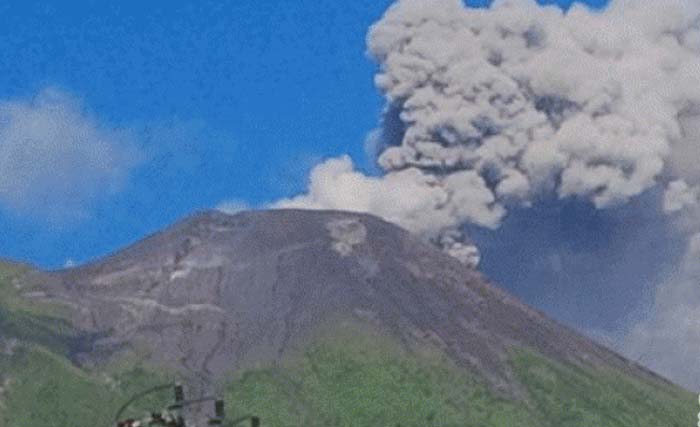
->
[0,210,694,427]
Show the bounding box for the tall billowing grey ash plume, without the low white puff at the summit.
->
[368,0,700,214]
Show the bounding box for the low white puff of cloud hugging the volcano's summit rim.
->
[272,156,502,235]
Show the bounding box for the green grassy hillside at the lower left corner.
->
[0,262,170,427]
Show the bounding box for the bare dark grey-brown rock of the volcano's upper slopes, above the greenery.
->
[37,210,663,396]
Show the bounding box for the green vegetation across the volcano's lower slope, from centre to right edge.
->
[226,322,697,427]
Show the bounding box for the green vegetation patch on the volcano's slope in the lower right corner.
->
[513,350,697,427]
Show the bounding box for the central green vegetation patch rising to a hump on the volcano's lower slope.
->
[226,320,536,427]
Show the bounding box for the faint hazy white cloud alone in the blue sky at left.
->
[0,88,139,220]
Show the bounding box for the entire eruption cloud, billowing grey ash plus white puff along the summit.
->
[276,0,700,387]
